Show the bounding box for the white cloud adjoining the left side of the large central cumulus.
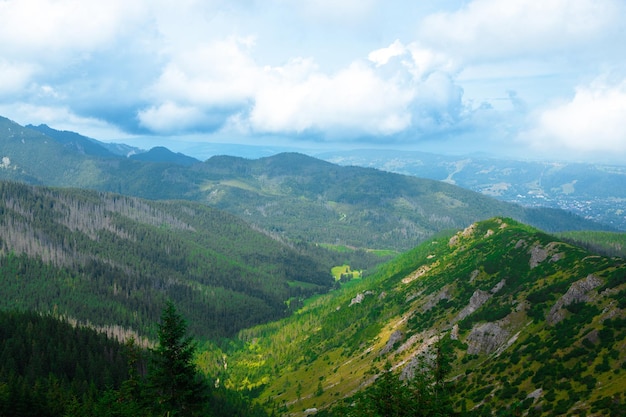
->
[137,38,262,133]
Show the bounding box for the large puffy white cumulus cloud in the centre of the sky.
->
[250,41,463,139]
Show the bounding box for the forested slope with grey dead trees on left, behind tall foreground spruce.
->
[0,182,334,337]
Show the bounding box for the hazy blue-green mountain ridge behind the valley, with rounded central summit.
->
[0,118,603,251]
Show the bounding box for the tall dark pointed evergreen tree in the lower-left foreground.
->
[148,302,207,417]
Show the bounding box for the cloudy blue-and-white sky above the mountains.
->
[0,0,626,164]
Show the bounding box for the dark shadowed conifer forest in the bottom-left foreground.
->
[0,310,266,417]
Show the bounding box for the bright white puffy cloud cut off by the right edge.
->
[520,77,626,154]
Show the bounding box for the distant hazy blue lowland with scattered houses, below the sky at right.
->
[318,149,626,230]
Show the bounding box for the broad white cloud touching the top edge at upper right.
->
[419,0,625,60]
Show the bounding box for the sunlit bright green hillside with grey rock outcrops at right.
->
[214,218,626,416]
